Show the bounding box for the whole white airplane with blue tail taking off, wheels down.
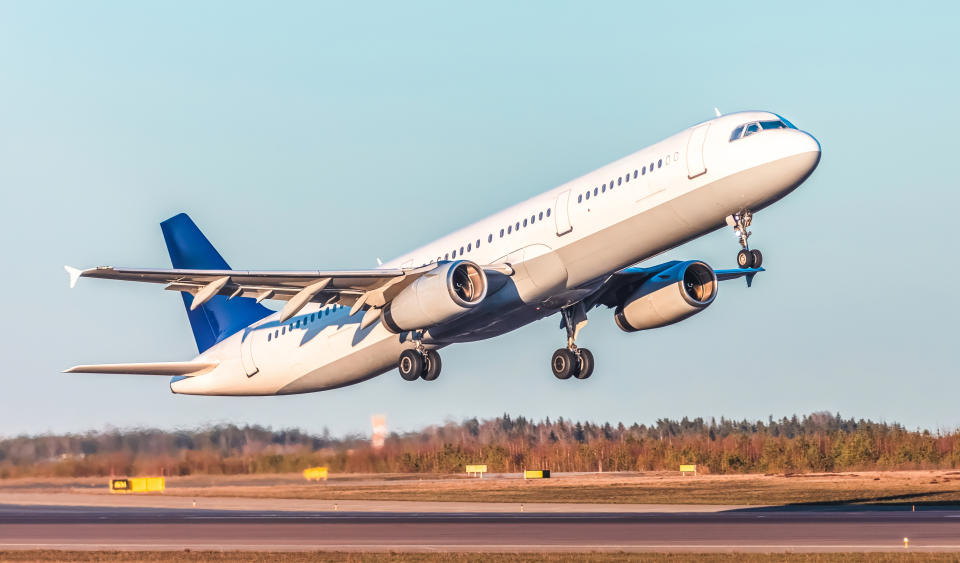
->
[65,111,821,396]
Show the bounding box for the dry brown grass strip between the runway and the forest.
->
[0,470,960,506]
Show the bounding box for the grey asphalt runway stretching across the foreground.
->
[0,505,960,552]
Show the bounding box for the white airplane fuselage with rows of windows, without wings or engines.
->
[171,112,820,395]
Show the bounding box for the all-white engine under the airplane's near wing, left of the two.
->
[383,260,487,333]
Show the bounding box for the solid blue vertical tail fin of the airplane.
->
[160,213,273,352]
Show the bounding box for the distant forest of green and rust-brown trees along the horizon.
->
[0,413,960,478]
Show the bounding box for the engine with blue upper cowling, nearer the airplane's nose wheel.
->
[614,262,717,332]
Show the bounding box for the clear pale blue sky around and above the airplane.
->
[0,1,960,435]
